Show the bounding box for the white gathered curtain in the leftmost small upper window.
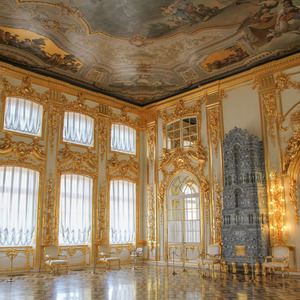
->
[4,97,43,136]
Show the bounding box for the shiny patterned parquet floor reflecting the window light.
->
[0,264,300,300]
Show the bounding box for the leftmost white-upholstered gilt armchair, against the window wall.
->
[44,245,69,274]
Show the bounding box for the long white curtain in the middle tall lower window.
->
[59,174,93,245]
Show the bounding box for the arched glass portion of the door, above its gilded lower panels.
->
[167,174,201,243]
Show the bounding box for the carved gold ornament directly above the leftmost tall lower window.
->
[0,133,46,168]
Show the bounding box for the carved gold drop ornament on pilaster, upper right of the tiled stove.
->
[263,93,277,147]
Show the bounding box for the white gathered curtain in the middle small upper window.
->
[63,111,94,146]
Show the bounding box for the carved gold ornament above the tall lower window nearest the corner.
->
[107,153,140,181]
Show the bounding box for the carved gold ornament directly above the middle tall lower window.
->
[58,143,98,177]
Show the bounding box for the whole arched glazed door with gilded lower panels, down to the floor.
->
[166,173,203,261]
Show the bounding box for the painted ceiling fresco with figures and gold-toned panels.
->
[0,0,300,105]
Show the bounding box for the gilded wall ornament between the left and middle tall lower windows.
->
[42,174,58,245]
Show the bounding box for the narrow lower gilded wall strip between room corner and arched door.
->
[146,187,156,253]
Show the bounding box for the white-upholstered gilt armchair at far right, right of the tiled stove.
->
[262,246,289,277]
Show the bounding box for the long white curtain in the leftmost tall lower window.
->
[0,166,39,246]
